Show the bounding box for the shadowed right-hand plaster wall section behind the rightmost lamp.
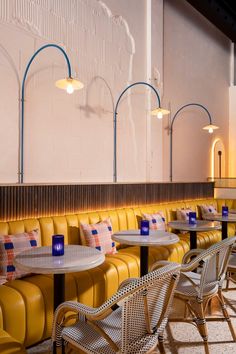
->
[163,0,230,181]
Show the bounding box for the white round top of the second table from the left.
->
[111,230,179,246]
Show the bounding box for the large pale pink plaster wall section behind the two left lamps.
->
[0,0,162,183]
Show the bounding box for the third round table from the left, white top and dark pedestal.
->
[168,220,221,249]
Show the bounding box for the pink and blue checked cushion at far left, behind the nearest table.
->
[0,230,39,284]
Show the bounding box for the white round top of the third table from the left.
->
[168,220,221,231]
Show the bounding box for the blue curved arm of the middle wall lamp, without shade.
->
[113,81,161,182]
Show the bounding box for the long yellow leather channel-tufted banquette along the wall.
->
[0,199,236,354]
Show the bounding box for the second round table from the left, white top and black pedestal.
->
[111,230,179,276]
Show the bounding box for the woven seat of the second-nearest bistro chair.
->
[175,272,218,298]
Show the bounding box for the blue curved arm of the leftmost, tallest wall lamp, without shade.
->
[19,43,71,183]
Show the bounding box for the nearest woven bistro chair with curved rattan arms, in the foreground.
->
[52,263,180,354]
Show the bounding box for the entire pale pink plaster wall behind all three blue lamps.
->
[0,0,230,183]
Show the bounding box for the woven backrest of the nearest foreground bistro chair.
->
[121,263,180,353]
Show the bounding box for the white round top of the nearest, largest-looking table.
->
[14,245,105,274]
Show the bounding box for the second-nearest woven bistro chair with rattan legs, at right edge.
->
[151,237,236,353]
